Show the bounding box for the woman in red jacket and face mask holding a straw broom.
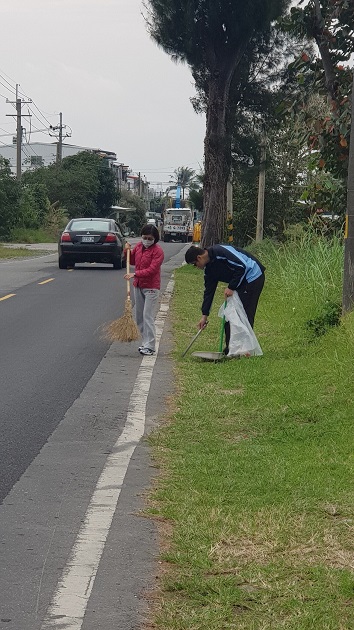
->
[124,224,164,355]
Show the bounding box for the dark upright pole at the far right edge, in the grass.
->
[342,68,354,314]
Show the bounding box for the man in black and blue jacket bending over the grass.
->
[185,245,265,354]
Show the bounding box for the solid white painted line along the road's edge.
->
[41,280,174,630]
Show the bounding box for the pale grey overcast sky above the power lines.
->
[0,0,205,193]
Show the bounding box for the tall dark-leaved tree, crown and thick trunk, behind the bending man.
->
[146,0,289,245]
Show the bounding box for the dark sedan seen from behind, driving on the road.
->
[58,218,125,269]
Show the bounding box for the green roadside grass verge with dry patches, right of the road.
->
[150,240,354,630]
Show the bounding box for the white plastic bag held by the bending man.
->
[219,291,263,357]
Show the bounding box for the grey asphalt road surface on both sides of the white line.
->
[0,243,185,630]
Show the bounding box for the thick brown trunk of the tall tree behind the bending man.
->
[201,75,231,247]
